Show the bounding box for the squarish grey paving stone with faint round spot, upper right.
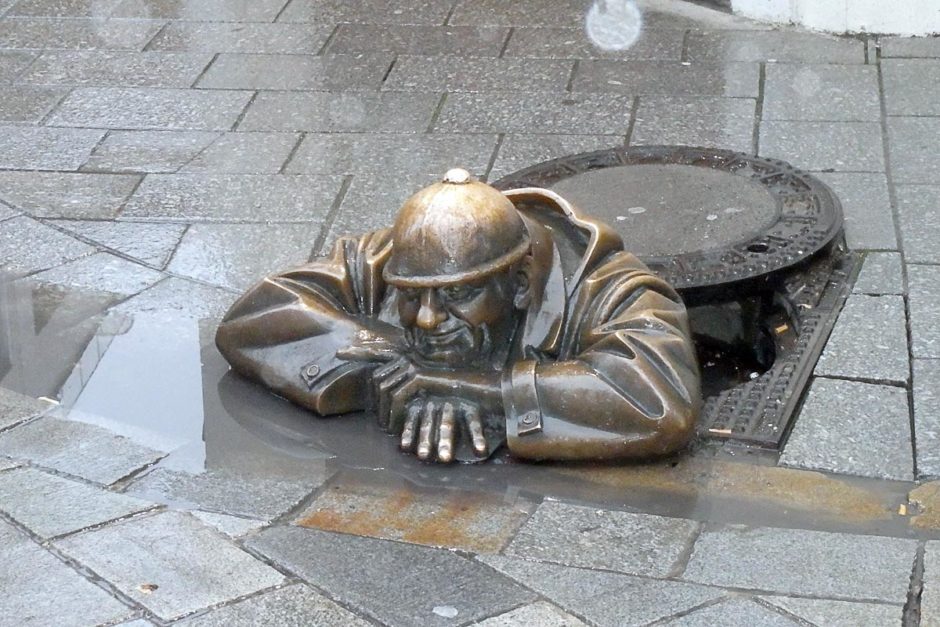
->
[762,63,881,122]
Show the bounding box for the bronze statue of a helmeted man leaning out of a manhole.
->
[216,169,701,462]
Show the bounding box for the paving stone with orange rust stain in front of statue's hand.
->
[295,482,534,553]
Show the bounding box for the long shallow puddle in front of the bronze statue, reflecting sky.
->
[0,281,928,537]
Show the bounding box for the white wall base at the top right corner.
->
[731,0,940,35]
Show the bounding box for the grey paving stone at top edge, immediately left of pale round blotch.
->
[448,0,585,26]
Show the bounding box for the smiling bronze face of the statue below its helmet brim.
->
[398,272,519,368]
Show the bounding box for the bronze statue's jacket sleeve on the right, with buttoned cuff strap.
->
[502,252,702,460]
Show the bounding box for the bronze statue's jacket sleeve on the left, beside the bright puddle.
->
[216,231,396,415]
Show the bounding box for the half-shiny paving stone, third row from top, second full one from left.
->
[197,53,392,91]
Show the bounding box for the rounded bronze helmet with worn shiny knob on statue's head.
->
[383,168,529,287]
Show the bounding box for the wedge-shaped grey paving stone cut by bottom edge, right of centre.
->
[477,556,725,627]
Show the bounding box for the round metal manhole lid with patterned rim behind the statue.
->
[493,146,842,291]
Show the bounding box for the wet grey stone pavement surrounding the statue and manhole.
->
[0,0,940,627]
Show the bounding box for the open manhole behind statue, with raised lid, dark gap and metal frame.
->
[494,146,858,449]
